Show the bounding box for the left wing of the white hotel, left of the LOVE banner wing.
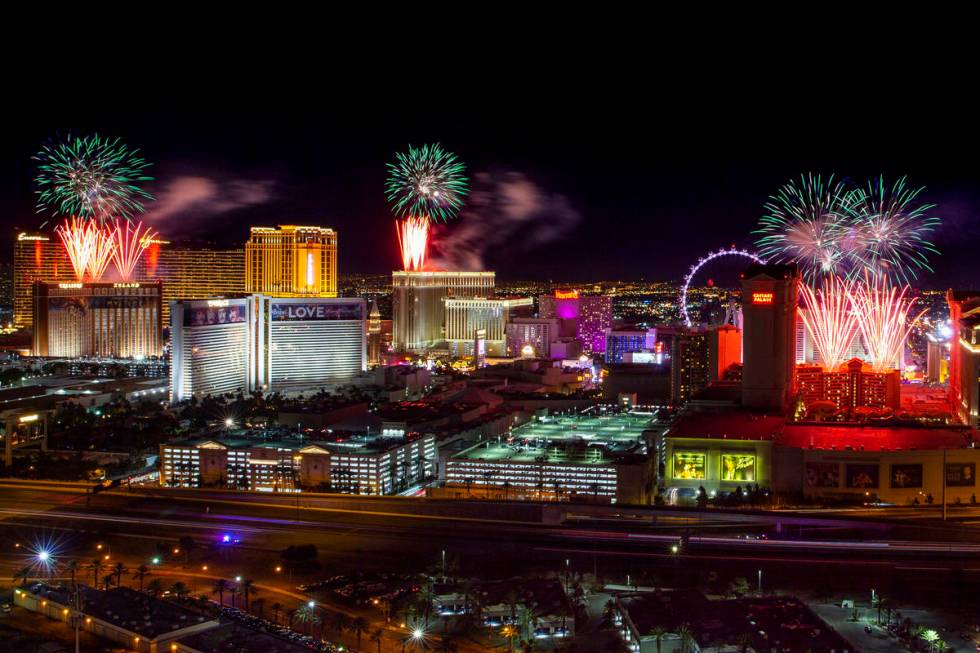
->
[170,297,253,402]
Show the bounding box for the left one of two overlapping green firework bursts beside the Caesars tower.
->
[755,174,850,280]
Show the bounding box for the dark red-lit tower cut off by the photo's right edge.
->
[946,290,980,427]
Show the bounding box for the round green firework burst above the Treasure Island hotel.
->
[34,134,153,223]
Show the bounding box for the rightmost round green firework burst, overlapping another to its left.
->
[845,177,939,283]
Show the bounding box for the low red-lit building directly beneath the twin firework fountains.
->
[796,358,901,410]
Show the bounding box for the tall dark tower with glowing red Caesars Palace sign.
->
[741,265,800,411]
